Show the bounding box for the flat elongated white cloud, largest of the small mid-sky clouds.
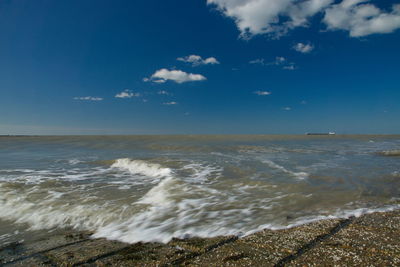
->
[143,69,207,83]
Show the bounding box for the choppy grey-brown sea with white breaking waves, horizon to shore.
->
[0,135,400,244]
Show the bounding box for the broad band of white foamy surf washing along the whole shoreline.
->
[0,176,400,243]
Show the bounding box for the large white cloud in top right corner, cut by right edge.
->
[324,0,400,37]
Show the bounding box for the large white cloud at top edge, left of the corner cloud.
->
[207,0,334,38]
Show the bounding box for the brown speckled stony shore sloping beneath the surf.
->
[0,211,400,266]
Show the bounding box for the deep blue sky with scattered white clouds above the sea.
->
[0,0,400,135]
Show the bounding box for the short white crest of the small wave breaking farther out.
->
[111,158,172,178]
